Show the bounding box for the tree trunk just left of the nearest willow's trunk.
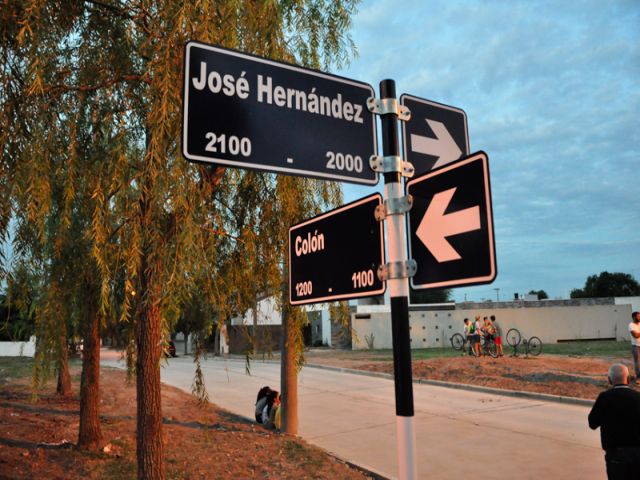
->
[78,290,102,450]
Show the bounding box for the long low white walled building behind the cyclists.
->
[351,297,640,350]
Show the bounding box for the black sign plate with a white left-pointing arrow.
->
[407,152,497,289]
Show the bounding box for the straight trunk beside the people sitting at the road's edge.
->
[280,286,298,435]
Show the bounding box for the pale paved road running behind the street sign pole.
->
[103,355,606,480]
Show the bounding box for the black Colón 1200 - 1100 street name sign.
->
[289,193,385,305]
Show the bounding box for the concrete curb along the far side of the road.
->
[305,363,595,407]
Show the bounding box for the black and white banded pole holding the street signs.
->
[367,80,418,480]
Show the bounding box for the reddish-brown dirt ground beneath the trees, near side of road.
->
[0,368,369,480]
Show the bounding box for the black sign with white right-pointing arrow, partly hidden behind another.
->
[400,94,469,176]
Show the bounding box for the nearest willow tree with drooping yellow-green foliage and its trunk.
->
[6,0,356,478]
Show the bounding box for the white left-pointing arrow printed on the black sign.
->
[416,188,480,263]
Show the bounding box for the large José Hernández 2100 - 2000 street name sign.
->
[182,41,378,185]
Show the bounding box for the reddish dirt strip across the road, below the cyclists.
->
[307,352,633,400]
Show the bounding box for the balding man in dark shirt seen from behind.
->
[589,363,640,480]
